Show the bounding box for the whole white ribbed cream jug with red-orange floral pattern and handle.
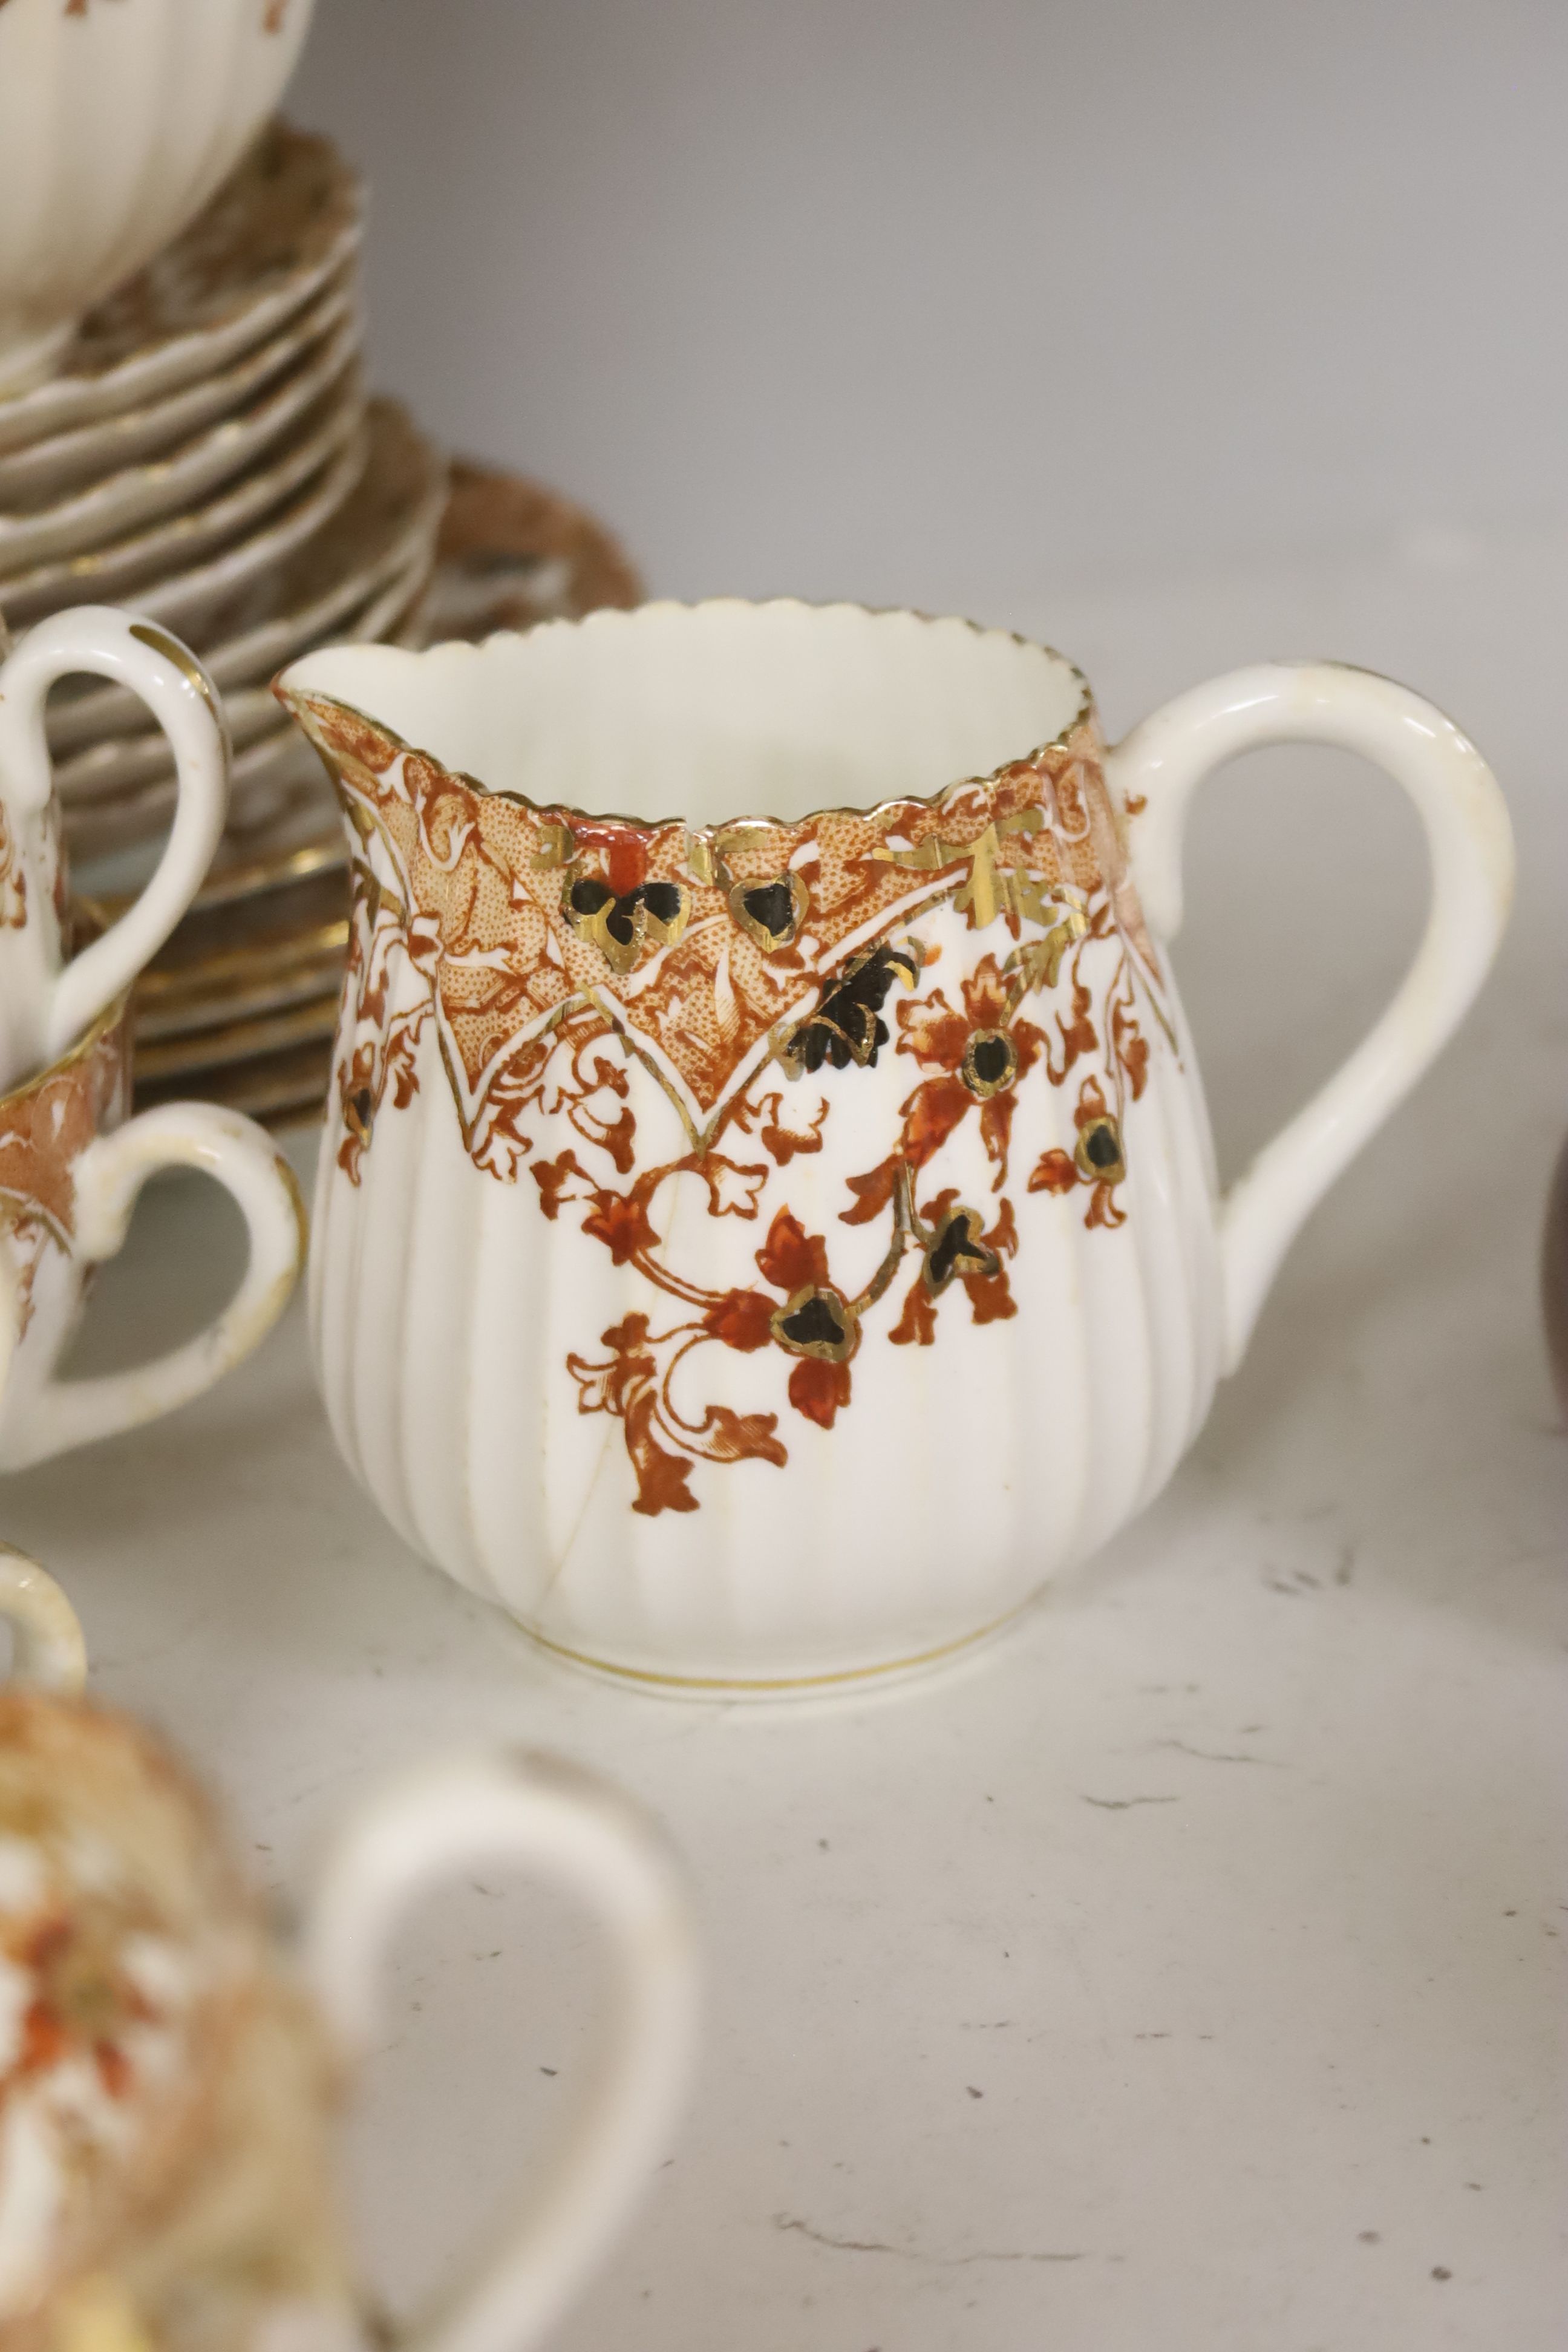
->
[279,602,1512,1689]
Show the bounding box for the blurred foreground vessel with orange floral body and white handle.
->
[0,1689,698,2352]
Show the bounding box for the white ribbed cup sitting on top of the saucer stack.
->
[0,0,313,388]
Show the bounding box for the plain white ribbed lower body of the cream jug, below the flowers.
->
[310,917,1220,1684]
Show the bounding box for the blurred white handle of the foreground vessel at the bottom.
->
[303,1753,698,2352]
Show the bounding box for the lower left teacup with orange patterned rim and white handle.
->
[0,999,305,1470]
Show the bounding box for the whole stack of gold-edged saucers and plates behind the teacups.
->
[0,125,639,1122]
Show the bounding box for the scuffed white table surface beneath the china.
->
[0,532,1568,2352]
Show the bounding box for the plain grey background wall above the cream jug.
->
[292,0,1568,619]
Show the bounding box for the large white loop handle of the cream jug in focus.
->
[1107,661,1514,1371]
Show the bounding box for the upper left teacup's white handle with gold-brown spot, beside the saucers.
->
[0,604,228,1068]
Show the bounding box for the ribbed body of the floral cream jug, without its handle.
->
[282,607,1220,1687]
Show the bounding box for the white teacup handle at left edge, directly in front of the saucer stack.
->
[0,604,228,1084]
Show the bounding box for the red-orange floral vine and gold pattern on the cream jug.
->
[294,696,1173,1515]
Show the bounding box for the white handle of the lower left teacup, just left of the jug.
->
[0,1103,305,1470]
